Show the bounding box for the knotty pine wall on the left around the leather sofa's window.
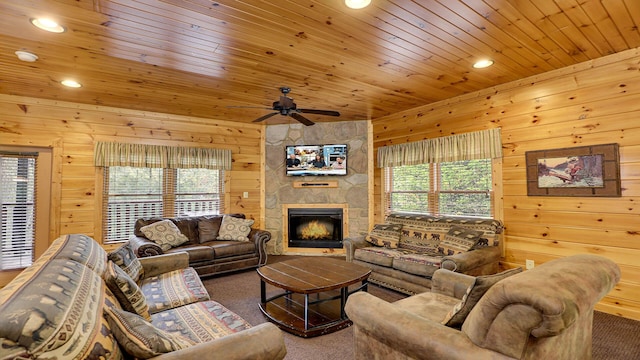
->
[0,95,264,253]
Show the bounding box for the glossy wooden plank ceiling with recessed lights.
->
[0,0,640,124]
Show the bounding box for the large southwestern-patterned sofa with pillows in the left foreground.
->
[0,234,286,360]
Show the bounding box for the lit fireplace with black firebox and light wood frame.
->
[282,204,348,254]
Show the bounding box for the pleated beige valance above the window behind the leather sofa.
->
[93,142,231,170]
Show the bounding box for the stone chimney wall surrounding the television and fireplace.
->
[264,120,373,256]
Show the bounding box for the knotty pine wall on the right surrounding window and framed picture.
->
[373,49,640,320]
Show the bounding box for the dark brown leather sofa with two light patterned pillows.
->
[129,214,271,276]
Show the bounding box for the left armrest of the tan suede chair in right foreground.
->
[345,292,512,360]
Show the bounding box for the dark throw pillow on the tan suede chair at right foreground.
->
[442,268,522,328]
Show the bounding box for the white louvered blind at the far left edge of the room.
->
[0,152,38,270]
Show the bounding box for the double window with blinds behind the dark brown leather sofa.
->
[103,166,224,243]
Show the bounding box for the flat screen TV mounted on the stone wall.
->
[285,144,347,176]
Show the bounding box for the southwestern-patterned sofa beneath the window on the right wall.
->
[344,213,503,295]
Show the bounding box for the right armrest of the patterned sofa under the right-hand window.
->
[441,246,502,276]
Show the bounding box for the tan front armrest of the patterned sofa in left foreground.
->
[152,323,287,360]
